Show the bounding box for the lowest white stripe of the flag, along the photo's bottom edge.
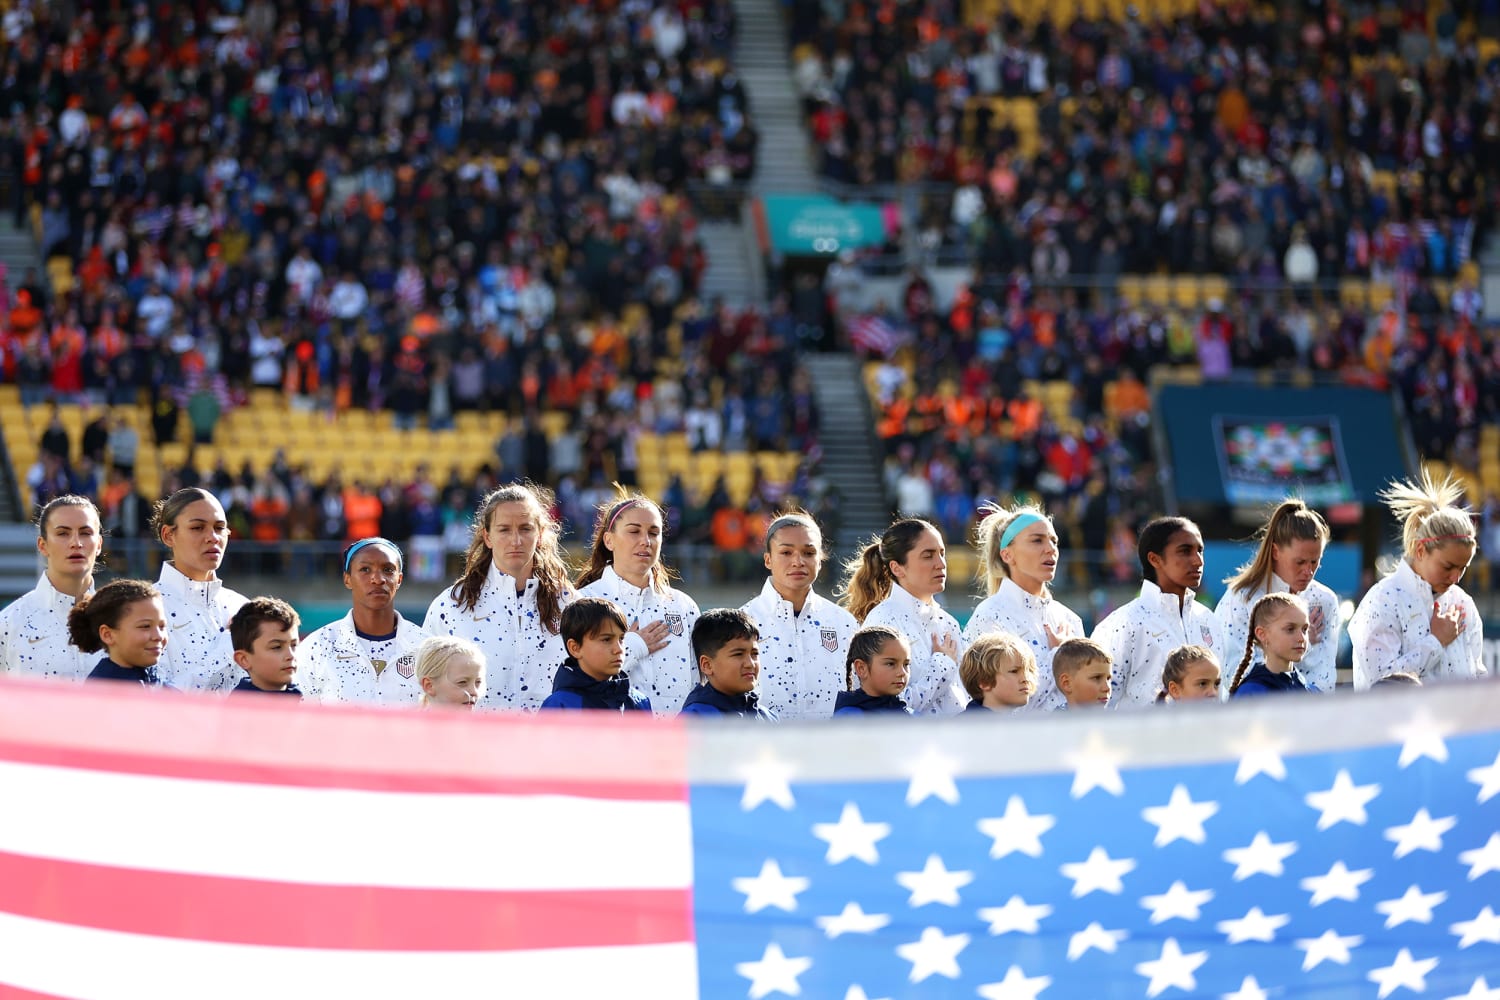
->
[0,917,698,1000]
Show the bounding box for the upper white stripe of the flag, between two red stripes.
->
[0,762,693,893]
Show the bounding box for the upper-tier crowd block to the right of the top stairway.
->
[792,0,1500,283]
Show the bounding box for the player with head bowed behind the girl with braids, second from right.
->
[1214,499,1338,694]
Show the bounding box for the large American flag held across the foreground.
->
[0,684,1500,1000]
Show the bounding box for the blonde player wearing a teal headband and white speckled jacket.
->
[963,504,1083,711]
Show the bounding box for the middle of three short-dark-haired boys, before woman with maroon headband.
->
[542,597,651,712]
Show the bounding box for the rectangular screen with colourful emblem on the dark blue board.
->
[1214,415,1355,505]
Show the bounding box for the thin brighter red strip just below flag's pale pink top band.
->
[0,739,687,802]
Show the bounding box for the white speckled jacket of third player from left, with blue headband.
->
[296,610,428,708]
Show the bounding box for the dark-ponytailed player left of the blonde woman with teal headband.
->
[840,517,969,715]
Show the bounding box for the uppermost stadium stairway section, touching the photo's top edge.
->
[734,0,818,195]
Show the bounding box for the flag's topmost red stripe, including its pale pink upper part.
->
[0,678,689,801]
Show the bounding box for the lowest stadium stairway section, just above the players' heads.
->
[803,354,891,558]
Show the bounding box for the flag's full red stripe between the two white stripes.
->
[0,851,693,952]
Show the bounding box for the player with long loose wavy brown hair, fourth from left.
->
[422,483,573,712]
